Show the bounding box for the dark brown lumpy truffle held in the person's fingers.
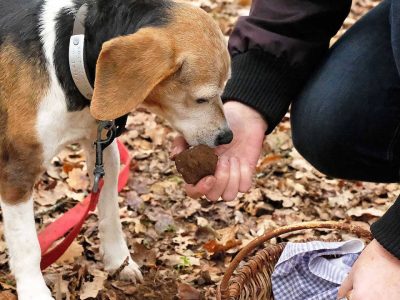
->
[175,145,218,184]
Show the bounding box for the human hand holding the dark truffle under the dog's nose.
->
[171,101,267,201]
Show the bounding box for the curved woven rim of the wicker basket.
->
[217,221,373,299]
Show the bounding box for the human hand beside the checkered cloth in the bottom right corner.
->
[338,240,400,300]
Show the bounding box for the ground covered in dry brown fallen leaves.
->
[0,0,390,300]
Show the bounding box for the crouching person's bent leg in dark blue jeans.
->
[291,1,400,182]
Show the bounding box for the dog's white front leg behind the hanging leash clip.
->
[85,141,143,282]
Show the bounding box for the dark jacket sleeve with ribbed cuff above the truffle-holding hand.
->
[222,0,351,133]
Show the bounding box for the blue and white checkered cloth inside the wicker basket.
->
[272,240,364,300]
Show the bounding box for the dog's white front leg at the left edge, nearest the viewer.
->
[0,196,53,300]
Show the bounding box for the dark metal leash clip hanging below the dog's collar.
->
[92,120,117,193]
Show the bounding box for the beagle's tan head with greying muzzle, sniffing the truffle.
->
[91,4,232,147]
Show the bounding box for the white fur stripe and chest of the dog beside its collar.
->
[36,0,96,164]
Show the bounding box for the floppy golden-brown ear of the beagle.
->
[90,27,178,120]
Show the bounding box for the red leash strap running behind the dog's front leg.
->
[39,141,131,270]
